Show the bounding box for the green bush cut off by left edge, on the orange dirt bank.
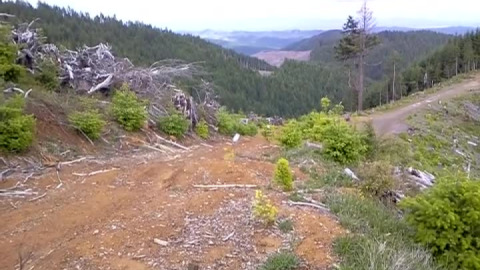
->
[0,95,35,152]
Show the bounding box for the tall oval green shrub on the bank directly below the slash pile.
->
[111,84,147,131]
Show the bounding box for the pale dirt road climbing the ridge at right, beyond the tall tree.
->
[370,74,480,136]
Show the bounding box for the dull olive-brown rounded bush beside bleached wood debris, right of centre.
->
[358,161,395,198]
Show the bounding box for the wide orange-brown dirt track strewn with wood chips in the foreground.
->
[0,138,343,270]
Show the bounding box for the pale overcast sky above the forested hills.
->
[28,0,480,31]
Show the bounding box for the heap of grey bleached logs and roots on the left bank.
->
[10,17,220,127]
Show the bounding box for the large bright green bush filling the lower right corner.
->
[401,176,480,269]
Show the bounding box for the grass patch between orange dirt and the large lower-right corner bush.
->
[326,192,440,270]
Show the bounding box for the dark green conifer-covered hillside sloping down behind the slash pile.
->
[0,1,349,116]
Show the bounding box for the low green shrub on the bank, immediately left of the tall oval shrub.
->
[68,110,105,140]
